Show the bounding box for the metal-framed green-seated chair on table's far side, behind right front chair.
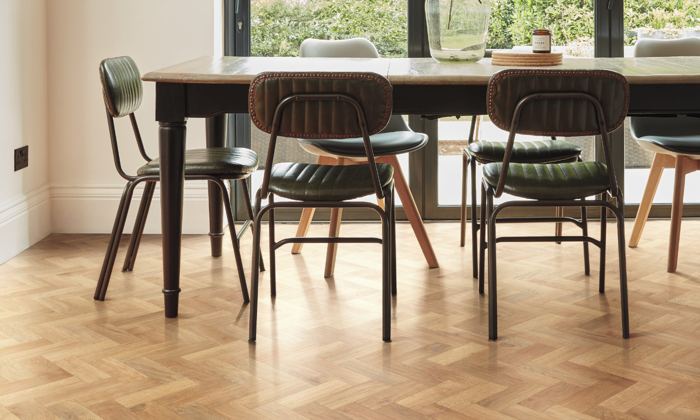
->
[459,111,589,278]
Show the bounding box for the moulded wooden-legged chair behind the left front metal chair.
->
[292,38,438,277]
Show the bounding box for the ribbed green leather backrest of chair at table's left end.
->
[100,57,143,118]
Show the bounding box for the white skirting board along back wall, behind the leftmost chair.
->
[51,181,227,234]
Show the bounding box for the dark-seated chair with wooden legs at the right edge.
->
[629,38,700,273]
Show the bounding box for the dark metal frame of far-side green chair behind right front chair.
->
[459,115,591,282]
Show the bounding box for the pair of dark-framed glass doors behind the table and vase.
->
[225,0,640,220]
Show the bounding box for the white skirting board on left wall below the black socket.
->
[0,184,52,264]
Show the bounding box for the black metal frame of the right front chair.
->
[479,92,630,340]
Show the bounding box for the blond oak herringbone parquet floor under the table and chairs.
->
[0,220,700,420]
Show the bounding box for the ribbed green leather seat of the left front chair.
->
[269,163,394,201]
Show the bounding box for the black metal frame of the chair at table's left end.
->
[94,108,265,303]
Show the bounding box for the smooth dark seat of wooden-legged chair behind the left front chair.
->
[297,131,428,157]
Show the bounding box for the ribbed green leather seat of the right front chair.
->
[484,162,610,200]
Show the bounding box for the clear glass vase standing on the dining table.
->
[425,0,490,61]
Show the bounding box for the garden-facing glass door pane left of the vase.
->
[250,0,408,205]
